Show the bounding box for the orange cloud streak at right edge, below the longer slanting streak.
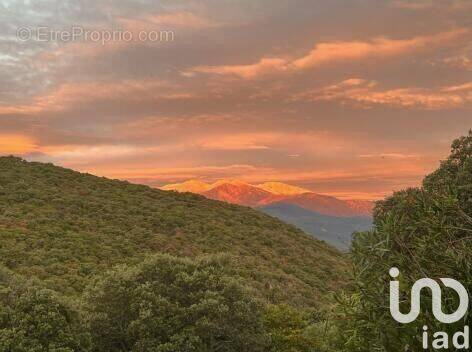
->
[295,79,472,110]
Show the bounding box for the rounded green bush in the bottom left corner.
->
[0,270,89,352]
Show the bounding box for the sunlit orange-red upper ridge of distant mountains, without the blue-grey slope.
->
[161,180,374,217]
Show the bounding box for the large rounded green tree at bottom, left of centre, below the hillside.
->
[81,255,264,352]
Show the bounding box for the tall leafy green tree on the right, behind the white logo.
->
[337,132,472,352]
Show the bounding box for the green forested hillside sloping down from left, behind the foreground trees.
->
[0,157,347,306]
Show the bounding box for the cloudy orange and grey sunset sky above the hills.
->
[0,0,472,199]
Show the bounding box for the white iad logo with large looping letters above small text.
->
[390,268,469,349]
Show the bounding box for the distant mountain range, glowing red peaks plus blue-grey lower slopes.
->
[161,180,374,251]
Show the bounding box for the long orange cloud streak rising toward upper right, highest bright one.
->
[187,29,469,79]
